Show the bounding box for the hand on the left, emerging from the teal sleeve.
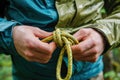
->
[13,26,56,63]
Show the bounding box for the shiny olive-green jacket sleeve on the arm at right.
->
[94,0,120,49]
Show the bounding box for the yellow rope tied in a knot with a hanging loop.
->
[42,29,78,80]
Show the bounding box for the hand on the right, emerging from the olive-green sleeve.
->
[72,28,104,62]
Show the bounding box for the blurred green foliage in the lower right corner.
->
[104,48,120,80]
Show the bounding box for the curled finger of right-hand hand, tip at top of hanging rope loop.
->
[71,38,95,54]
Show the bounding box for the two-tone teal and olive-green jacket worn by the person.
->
[0,0,120,80]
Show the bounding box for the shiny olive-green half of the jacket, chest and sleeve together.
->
[56,0,120,52]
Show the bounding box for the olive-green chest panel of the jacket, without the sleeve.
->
[55,0,104,32]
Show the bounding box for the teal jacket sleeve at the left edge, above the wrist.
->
[0,18,20,54]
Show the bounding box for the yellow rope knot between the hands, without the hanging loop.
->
[53,29,78,47]
